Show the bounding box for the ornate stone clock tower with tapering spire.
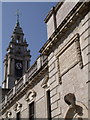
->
[3,11,31,89]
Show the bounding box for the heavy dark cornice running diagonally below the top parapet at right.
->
[39,2,90,55]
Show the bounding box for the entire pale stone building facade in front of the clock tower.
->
[1,0,90,120]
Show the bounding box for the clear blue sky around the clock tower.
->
[0,2,57,84]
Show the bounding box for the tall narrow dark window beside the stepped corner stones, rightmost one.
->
[47,90,51,120]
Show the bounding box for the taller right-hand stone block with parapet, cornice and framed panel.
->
[40,1,90,118]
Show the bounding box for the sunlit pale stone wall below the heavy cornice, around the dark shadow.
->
[48,11,90,118]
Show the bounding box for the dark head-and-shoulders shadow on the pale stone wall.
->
[64,93,88,120]
